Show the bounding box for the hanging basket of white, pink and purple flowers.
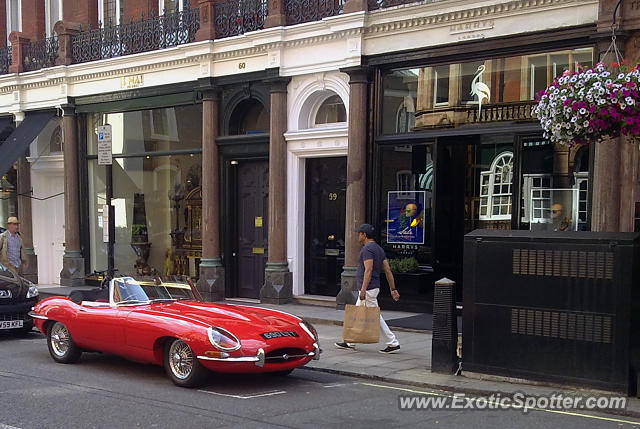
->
[534,62,640,146]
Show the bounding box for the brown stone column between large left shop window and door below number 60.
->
[198,87,224,301]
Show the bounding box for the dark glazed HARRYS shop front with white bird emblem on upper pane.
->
[373,43,594,309]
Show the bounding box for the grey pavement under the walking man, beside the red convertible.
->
[38,285,640,418]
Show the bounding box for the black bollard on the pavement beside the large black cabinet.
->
[431,277,458,374]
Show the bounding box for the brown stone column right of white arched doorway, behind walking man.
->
[336,67,369,308]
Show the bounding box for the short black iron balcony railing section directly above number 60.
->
[215,0,268,39]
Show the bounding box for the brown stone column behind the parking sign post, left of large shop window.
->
[60,104,84,286]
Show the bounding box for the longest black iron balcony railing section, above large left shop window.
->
[71,0,200,63]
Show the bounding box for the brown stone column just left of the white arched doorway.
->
[260,77,293,304]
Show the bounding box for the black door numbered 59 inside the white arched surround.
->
[304,157,347,296]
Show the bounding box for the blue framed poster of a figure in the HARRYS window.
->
[387,191,426,244]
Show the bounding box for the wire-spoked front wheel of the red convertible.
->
[164,339,207,387]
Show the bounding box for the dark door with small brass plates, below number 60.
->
[232,160,269,298]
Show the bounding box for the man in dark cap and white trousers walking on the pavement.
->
[335,223,400,353]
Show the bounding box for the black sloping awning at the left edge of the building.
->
[0,111,56,175]
